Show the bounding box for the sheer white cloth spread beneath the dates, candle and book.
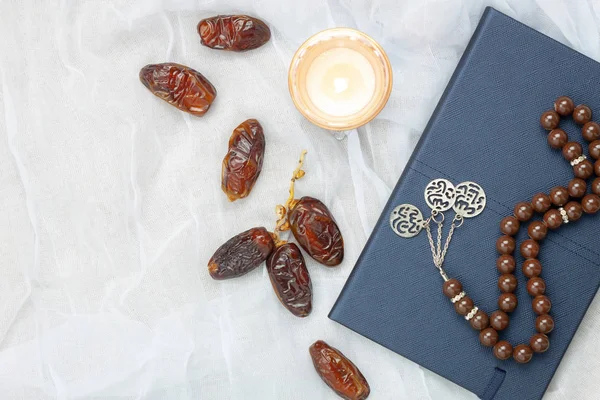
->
[0,0,600,400]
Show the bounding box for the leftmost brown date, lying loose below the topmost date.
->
[140,63,217,116]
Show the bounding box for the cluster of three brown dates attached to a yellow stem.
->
[208,151,344,317]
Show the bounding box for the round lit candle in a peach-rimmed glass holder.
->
[288,28,392,131]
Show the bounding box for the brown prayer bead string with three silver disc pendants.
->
[390,96,600,363]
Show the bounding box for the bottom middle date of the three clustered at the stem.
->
[267,243,312,317]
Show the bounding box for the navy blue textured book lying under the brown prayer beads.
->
[329,8,600,400]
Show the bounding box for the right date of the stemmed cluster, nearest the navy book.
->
[289,196,344,267]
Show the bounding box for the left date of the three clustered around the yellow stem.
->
[208,227,275,280]
